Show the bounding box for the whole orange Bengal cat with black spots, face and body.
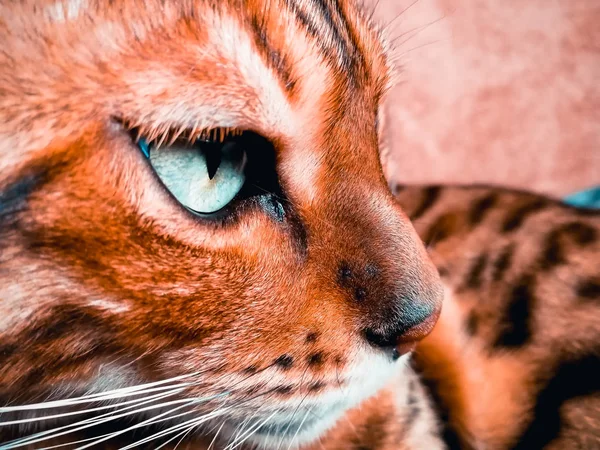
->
[0,0,600,450]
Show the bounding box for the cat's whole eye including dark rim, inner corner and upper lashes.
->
[126,123,287,221]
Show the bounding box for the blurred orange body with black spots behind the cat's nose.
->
[394,186,600,449]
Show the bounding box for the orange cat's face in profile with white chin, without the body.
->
[0,1,441,444]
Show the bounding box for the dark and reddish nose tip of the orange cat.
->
[363,302,440,359]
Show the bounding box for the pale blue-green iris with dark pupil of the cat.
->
[138,134,247,214]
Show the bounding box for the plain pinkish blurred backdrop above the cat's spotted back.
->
[365,0,600,197]
